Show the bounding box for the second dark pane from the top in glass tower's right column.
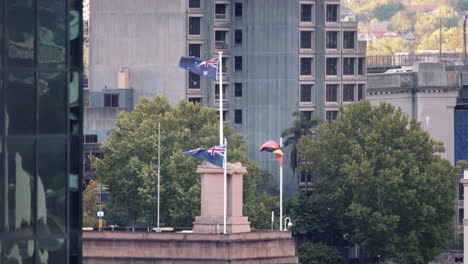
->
[37,73,67,134]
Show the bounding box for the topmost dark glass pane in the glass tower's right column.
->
[37,0,67,67]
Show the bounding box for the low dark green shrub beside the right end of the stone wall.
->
[298,243,343,264]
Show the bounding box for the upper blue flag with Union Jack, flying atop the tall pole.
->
[179,56,219,80]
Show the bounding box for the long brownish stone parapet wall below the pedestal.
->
[83,230,298,264]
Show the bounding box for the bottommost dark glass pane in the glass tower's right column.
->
[37,238,67,264]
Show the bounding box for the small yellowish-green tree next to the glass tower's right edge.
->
[83,181,99,227]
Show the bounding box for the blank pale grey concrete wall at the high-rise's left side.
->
[89,0,188,103]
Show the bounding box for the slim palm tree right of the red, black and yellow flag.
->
[281,111,319,172]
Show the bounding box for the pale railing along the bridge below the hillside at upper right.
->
[366,53,463,67]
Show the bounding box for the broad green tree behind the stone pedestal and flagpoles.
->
[94,96,276,227]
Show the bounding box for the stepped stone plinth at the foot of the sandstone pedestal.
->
[193,216,250,234]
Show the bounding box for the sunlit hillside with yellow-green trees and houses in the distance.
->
[343,0,468,55]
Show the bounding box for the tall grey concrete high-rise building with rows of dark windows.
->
[85,0,366,191]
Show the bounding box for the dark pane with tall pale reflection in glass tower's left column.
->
[5,138,34,235]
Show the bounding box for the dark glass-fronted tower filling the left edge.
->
[0,0,82,264]
